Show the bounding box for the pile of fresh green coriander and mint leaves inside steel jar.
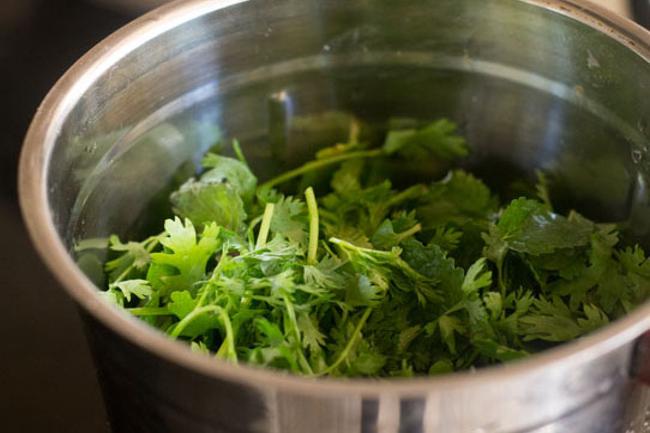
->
[79,119,650,377]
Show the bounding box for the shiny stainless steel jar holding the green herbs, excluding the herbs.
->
[20,0,650,433]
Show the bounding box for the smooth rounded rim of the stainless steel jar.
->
[18,0,650,396]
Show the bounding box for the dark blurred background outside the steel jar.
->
[0,0,650,433]
